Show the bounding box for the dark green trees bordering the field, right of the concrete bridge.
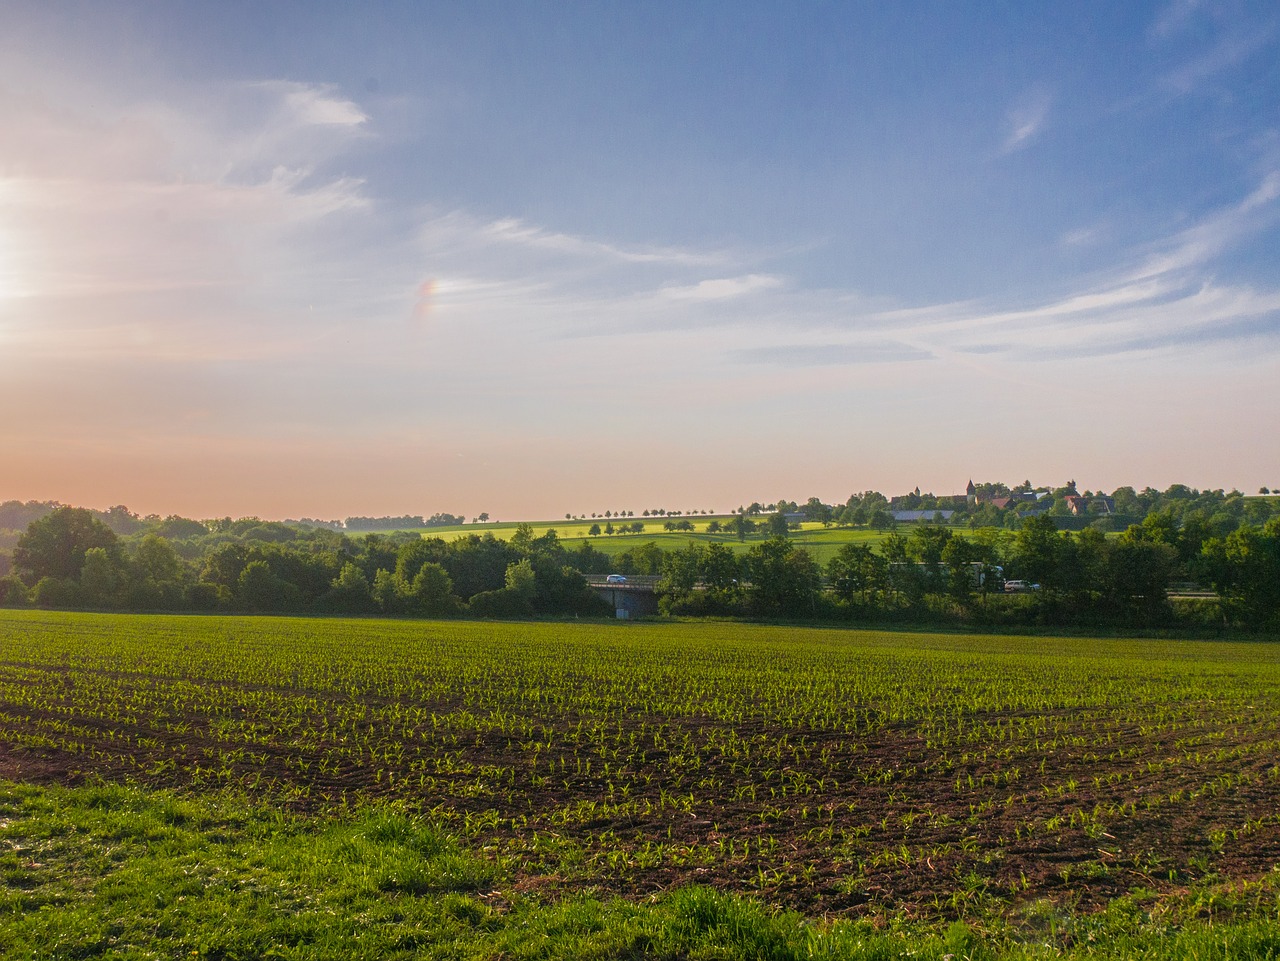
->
[645,513,1280,631]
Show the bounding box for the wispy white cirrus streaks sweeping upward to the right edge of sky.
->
[696,175,1280,366]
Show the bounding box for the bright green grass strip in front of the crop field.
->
[0,782,1280,961]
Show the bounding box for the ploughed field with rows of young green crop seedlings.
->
[0,612,1280,919]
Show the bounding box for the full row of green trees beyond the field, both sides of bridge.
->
[0,507,1280,630]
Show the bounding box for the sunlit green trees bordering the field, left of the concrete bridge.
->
[0,507,611,617]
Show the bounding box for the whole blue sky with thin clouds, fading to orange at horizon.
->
[0,0,1280,520]
